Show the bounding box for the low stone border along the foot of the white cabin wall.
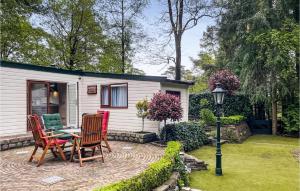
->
[0,131,157,151]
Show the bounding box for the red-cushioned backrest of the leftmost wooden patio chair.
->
[27,114,47,146]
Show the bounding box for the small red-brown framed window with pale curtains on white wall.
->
[101,84,128,108]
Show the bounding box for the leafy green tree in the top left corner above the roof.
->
[0,0,50,65]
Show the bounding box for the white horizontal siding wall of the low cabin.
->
[0,67,188,136]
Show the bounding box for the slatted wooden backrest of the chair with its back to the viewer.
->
[80,114,102,146]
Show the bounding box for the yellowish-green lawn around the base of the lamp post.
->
[189,135,300,191]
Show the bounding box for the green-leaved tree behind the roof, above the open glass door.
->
[46,0,107,70]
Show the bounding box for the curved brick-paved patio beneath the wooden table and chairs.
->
[0,141,163,191]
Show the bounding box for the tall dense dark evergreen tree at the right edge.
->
[214,0,299,134]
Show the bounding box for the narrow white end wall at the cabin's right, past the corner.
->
[161,84,189,121]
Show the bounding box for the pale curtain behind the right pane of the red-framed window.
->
[111,85,127,107]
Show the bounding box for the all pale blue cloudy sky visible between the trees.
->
[30,0,215,76]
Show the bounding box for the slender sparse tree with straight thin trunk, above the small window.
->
[99,0,148,73]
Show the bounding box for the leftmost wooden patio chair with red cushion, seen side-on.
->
[27,115,67,166]
